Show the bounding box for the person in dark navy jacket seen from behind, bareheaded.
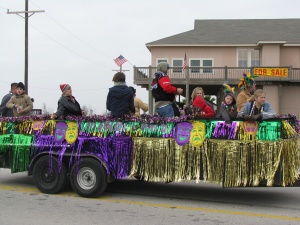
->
[106,72,135,117]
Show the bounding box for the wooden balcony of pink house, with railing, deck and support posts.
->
[133,66,300,112]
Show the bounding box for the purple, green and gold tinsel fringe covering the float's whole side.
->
[0,116,298,187]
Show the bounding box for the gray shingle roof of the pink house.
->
[146,18,300,48]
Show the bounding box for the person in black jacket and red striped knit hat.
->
[52,84,82,118]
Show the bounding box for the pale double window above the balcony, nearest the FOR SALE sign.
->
[237,48,260,67]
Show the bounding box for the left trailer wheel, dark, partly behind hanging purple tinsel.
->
[33,155,68,194]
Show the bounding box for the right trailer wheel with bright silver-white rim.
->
[70,158,107,198]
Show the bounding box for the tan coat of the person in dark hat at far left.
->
[6,94,33,117]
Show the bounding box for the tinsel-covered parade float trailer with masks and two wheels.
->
[0,115,299,197]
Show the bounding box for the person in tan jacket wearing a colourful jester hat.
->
[236,73,258,112]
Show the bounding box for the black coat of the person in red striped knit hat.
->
[55,95,82,118]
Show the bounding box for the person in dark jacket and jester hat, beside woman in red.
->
[217,84,237,127]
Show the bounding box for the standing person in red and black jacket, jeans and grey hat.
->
[151,62,183,117]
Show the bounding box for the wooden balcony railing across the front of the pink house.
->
[134,66,300,84]
